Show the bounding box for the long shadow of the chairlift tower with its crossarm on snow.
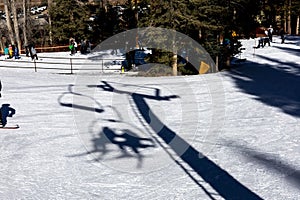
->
[89,81,262,199]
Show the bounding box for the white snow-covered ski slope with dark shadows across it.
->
[0,37,300,200]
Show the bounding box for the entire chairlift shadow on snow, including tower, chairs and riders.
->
[59,81,261,199]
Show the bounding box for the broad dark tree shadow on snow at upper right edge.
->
[226,55,300,117]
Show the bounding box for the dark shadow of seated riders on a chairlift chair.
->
[89,127,155,168]
